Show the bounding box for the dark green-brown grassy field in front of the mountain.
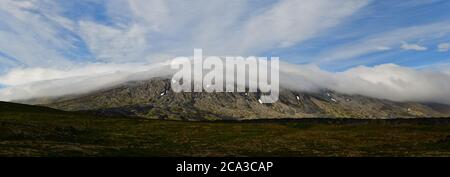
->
[0,102,450,156]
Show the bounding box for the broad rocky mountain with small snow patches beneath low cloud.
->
[21,78,450,120]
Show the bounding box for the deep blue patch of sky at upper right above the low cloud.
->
[262,0,450,71]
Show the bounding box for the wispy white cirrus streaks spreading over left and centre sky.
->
[0,0,369,68]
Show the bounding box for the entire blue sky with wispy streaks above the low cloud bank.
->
[0,0,450,103]
